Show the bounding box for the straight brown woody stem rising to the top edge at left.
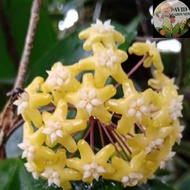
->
[14,0,41,88]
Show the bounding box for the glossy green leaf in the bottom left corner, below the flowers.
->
[0,158,62,190]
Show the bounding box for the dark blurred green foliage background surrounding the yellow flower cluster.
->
[0,0,190,190]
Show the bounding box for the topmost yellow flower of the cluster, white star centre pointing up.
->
[79,20,125,51]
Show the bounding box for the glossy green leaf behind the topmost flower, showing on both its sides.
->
[27,16,140,82]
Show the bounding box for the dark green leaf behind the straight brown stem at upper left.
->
[4,0,57,83]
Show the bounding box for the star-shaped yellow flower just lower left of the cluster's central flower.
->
[42,100,86,152]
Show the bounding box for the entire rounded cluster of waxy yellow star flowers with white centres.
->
[14,20,183,189]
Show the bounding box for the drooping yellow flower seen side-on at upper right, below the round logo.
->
[128,40,163,71]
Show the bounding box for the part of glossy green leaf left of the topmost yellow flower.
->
[27,28,89,83]
